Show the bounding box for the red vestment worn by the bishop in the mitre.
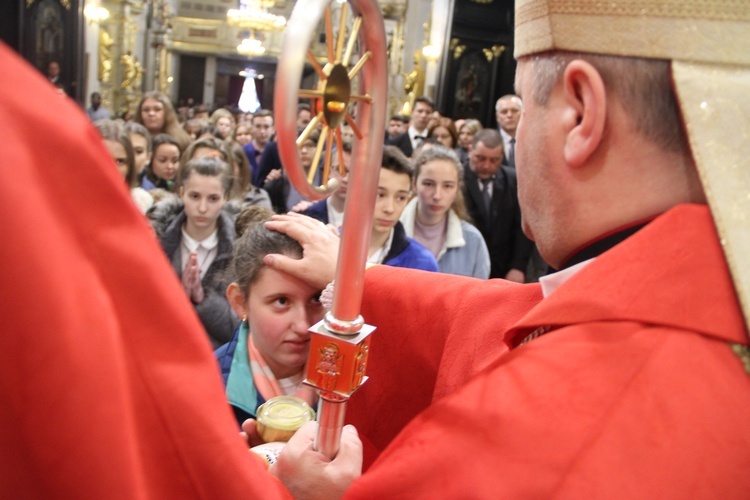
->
[347,205,750,498]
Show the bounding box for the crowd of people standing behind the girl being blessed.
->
[83,83,546,347]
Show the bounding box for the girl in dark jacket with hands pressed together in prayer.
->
[149,156,238,348]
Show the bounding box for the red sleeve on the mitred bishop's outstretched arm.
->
[347,266,541,468]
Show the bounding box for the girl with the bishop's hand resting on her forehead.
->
[216,207,325,425]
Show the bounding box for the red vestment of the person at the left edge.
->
[0,44,288,499]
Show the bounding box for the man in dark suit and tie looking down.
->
[464,129,533,283]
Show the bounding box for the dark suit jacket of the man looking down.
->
[464,167,534,278]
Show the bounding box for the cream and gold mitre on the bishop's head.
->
[515,0,750,332]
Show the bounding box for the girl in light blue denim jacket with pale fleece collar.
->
[401,146,490,279]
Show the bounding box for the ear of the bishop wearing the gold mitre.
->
[563,59,607,167]
